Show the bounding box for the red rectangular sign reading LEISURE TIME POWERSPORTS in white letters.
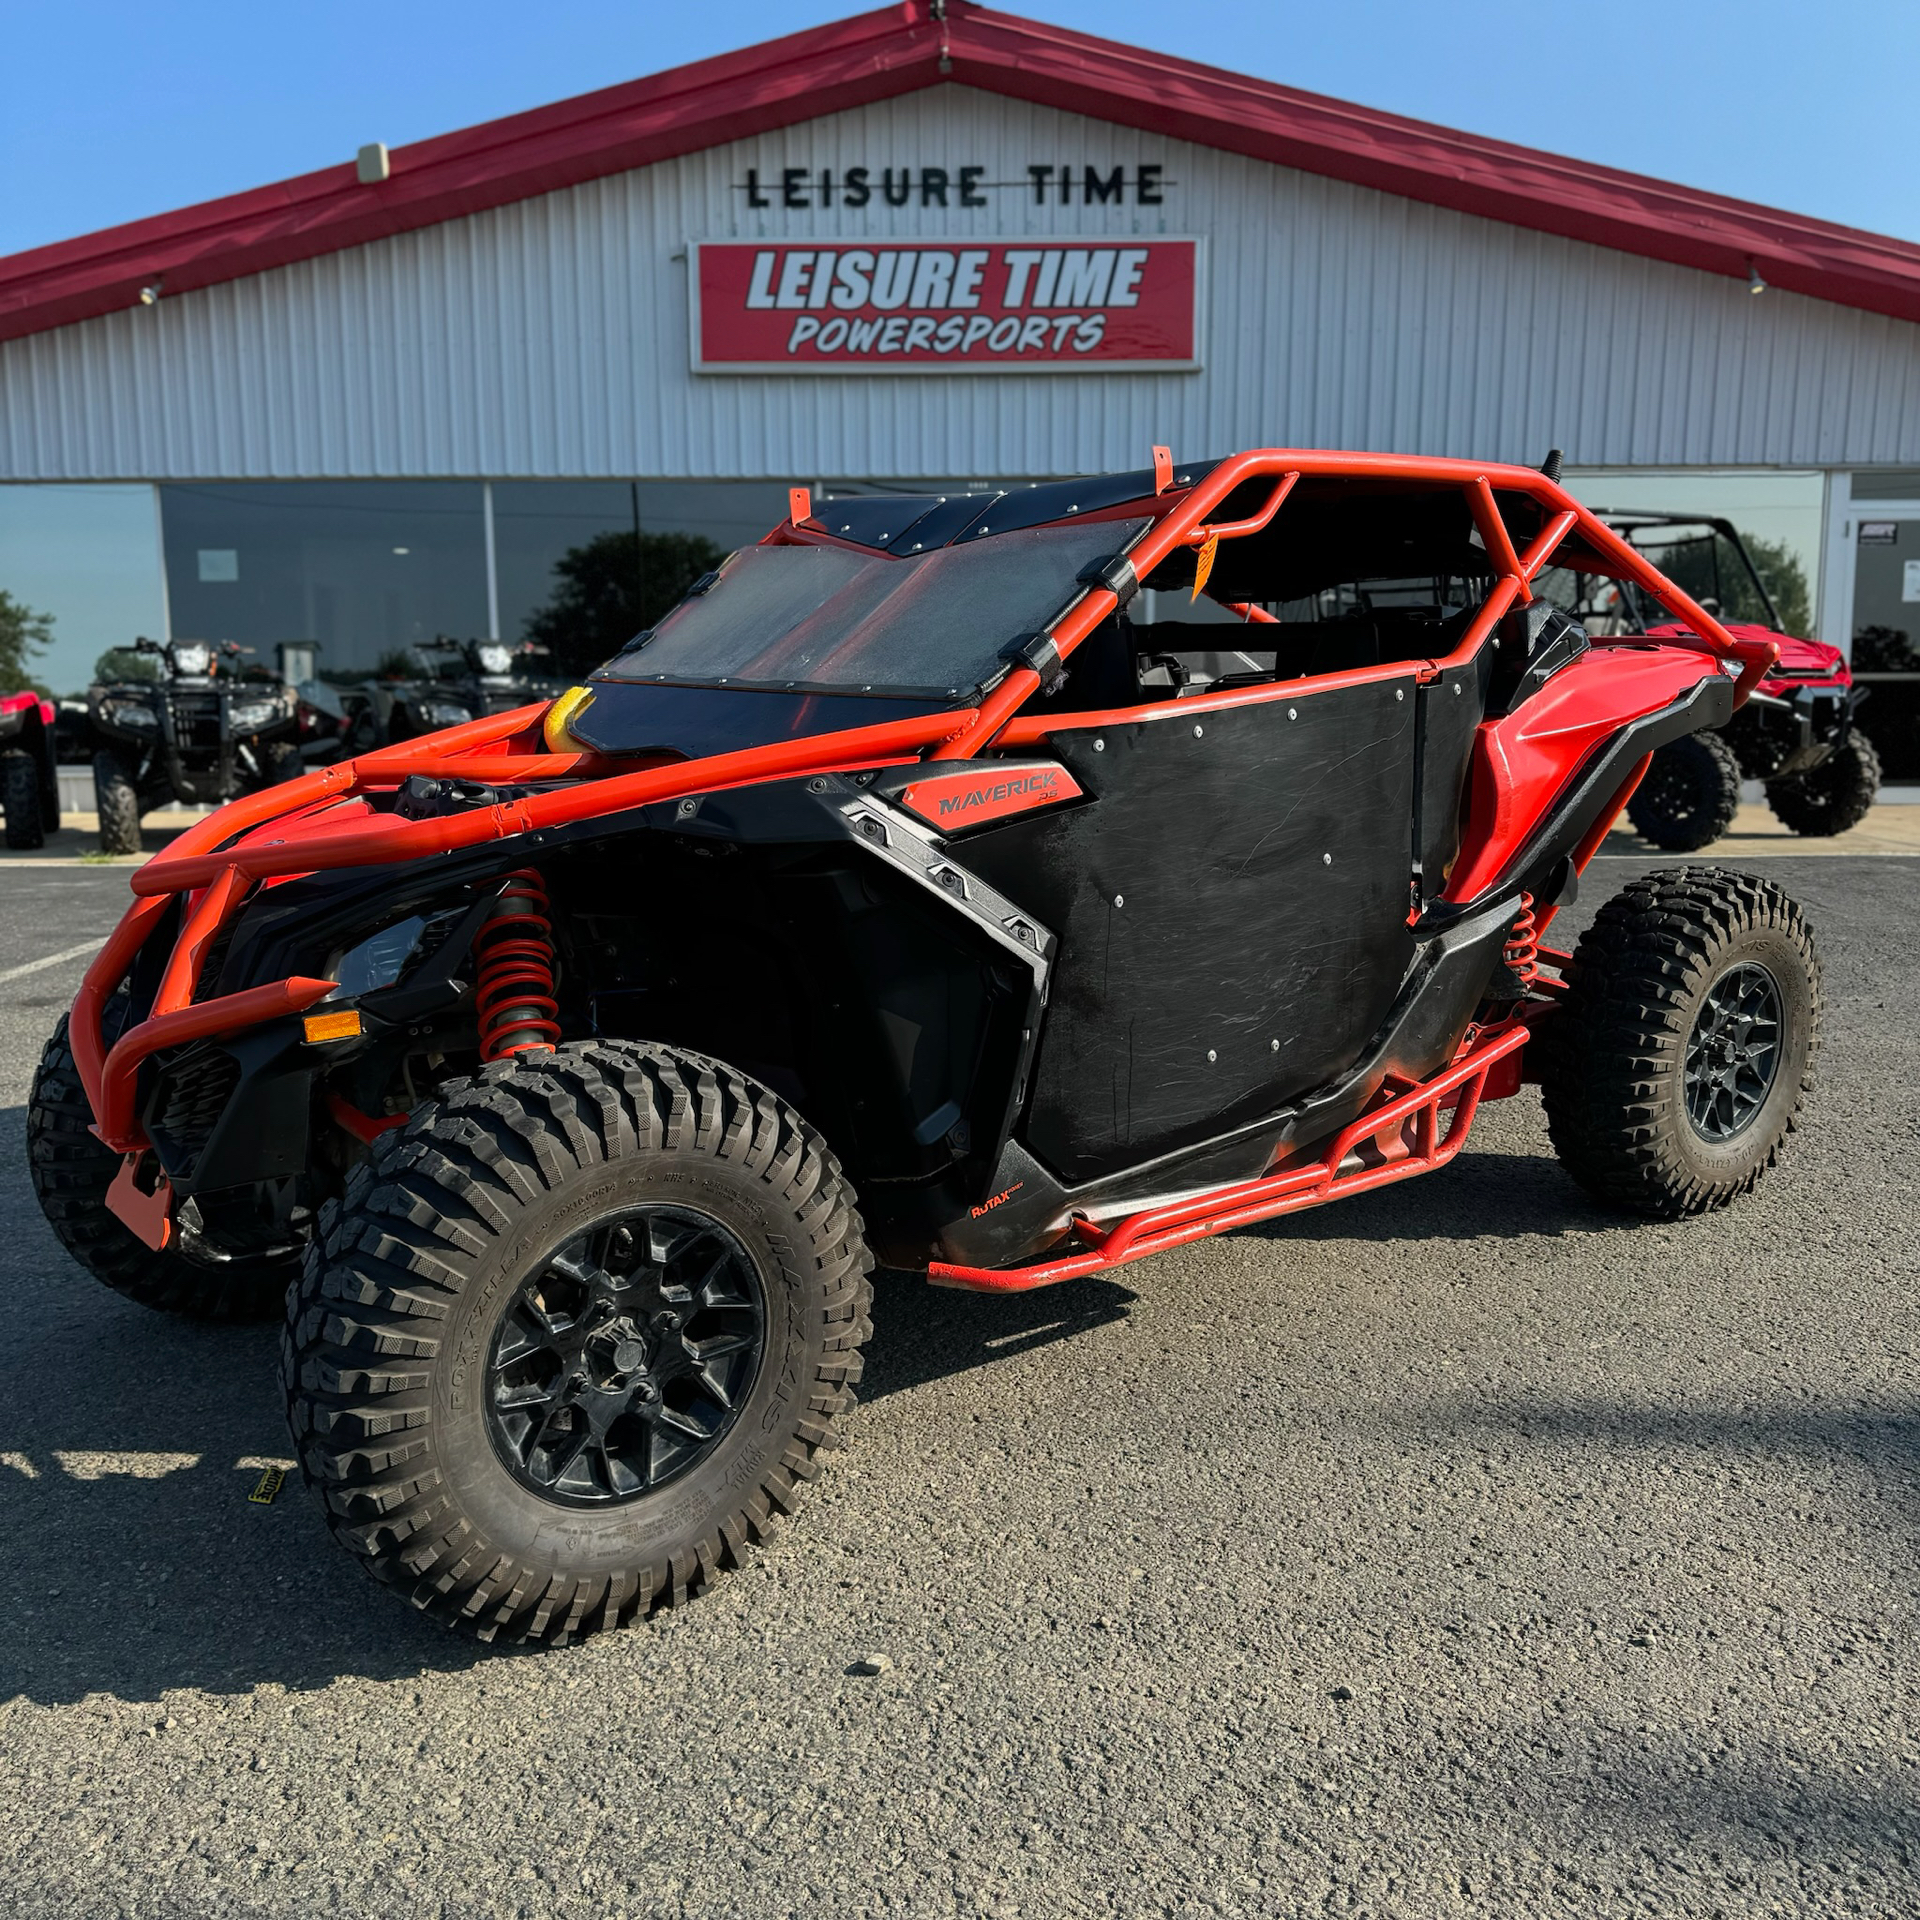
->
[687,238,1200,372]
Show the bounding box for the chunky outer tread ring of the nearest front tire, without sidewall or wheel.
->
[280,1041,874,1644]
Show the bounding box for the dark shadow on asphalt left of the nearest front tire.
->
[0,1290,518,1705]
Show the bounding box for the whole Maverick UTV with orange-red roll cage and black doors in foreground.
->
[29,449,1820,1642]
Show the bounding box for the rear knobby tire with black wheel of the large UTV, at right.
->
[1540,866,1820,1219]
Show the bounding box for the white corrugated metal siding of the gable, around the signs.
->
[0,88,1920,480]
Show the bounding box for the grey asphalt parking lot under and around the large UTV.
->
[0,844,1920,1920]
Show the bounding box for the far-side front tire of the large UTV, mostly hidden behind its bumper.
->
[27,1016,294,1321]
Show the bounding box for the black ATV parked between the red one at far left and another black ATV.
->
[86,639,303,852]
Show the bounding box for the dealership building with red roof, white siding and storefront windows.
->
[0,0,1920,689]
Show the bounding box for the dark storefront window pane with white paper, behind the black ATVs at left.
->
[159,480,488,676]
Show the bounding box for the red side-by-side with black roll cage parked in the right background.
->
[1566,509,1880,852]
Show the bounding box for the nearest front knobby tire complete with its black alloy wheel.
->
[282,1041,874,1644]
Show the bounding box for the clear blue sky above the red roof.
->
[0,0,1920,253]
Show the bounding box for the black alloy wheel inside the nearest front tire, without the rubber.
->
[488,1206,766,1507]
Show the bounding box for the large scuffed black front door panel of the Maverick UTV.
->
[964,674,1417,1183]
